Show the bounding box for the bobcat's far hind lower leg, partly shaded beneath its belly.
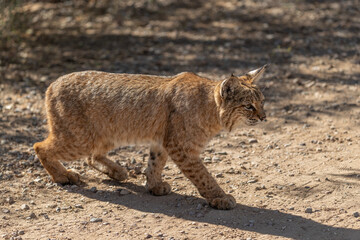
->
[87,155,128,181]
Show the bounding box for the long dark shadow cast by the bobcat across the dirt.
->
[68,181,360,240]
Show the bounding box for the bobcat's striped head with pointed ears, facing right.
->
[216,65,268,131]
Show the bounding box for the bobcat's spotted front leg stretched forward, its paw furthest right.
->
[169,150,236,210]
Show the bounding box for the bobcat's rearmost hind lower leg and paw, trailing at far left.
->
[34,138,81,185]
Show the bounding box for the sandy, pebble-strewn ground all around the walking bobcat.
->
[0,0,360,240]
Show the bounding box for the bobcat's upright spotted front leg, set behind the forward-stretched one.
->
[146,145,171,196]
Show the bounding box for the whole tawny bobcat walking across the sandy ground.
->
[34,65,267,209]
